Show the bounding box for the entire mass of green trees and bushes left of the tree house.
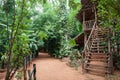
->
[0,0,82,80]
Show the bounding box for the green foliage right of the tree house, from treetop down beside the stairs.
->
[97,0,120,67]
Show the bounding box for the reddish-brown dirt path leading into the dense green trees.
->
[27,53,104,80]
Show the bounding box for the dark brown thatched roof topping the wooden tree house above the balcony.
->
[77,0,95,22]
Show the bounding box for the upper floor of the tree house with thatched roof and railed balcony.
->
[77,0,96,32]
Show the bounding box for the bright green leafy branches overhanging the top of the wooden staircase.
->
[98,0,120,29]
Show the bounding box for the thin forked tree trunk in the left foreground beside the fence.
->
[5,0,25,80]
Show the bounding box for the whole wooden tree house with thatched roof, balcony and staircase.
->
[75,0,113,75]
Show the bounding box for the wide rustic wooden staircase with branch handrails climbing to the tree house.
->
[83,22,113,76]
